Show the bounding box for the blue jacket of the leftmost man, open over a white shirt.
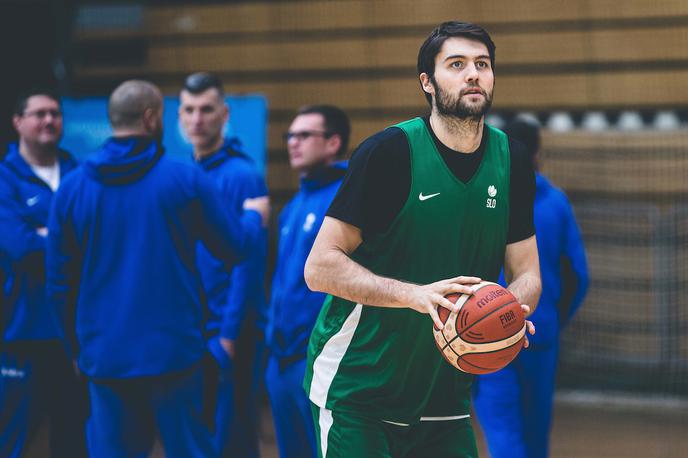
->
[0,144,77,341]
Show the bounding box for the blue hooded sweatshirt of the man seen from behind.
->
[47,137,260,378]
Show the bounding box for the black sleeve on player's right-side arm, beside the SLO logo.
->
[507,139,535,243]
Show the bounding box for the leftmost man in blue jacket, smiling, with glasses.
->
[0,90,87,457]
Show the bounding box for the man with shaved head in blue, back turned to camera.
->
[47,80,268,457]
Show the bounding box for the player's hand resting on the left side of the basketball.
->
[408,276,481,329]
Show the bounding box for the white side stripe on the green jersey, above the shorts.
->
[309,304,363,407]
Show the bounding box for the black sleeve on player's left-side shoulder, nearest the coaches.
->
[327,127,411,240]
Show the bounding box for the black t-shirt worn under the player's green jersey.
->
[327,116,535,243]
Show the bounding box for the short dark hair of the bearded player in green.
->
[418,21,496,105]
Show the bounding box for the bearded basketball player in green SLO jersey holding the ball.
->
[304,22,540,457]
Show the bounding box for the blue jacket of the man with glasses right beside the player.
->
[266,162,346,359]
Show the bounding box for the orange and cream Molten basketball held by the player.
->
[433,281,526,374]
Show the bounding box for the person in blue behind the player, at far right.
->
[473,118,588,458]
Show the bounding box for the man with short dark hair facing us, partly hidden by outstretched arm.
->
[179,73,267,458]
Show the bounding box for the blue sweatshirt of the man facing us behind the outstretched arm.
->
[198,141,268,340]
